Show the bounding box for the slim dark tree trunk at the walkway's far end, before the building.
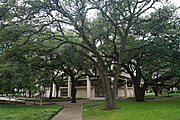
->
[71,77,77,103]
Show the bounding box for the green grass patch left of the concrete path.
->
[0,104,63,120]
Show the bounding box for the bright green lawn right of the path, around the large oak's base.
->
[83,96,180,120]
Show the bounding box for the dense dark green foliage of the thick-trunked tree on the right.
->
[124,5,180,82]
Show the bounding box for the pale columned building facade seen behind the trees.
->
[44,77,134,98]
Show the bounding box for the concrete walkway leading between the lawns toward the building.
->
[51,101,83,120]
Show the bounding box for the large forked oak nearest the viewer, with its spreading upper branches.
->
[1,0,169,109]
